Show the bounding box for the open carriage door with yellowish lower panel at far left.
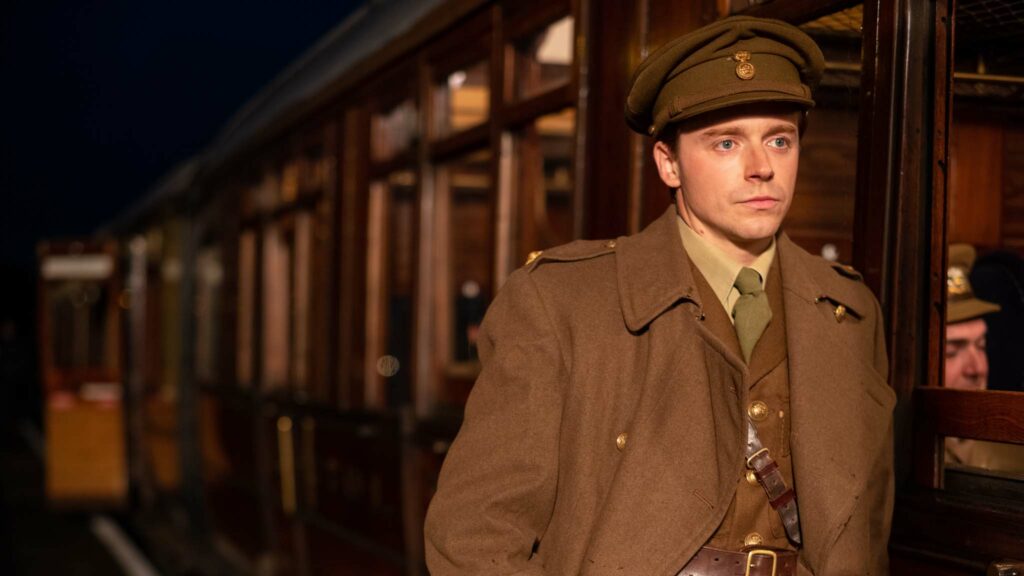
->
[38,242,128,506]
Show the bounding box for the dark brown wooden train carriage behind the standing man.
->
[41,0,1024,575]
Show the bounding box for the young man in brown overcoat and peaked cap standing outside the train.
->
[426,16,895,576]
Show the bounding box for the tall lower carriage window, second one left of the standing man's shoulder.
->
[437,151,495,405]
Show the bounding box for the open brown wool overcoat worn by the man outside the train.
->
[426,209,895,576]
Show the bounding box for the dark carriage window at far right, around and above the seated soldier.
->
[946,1,1024,392]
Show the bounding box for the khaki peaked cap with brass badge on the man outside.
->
[626,16,824,136]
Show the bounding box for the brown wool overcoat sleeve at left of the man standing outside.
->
[424,271,567,576]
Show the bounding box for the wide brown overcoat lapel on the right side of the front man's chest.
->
[778,235,893,571]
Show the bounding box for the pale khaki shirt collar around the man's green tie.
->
[676,214,775,320]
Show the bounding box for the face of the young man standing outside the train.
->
[654,105,800,255]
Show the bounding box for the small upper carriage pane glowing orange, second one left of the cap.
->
[434,60,490,136]
